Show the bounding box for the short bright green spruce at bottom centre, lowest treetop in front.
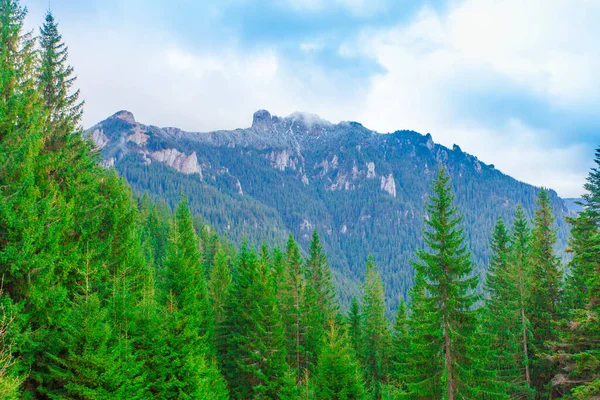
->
[316,323,366,400]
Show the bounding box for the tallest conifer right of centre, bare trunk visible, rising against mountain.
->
[408,169,478,400]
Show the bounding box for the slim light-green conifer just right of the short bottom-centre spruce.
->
[360,256,392,399]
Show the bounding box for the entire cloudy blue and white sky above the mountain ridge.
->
[22,0,600,197]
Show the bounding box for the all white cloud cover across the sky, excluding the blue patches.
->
[23,0,600,196]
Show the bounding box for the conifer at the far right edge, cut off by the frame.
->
[550,148,600,400]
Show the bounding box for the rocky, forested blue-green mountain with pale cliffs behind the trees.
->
[87,110,569,308]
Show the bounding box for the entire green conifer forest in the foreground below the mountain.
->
[0,0,600,400]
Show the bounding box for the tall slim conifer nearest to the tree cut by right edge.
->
[529,190,562,396]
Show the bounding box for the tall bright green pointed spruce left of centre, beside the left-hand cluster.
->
[148,199,227,399]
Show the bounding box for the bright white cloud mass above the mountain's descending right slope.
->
[340,0,600,196]
